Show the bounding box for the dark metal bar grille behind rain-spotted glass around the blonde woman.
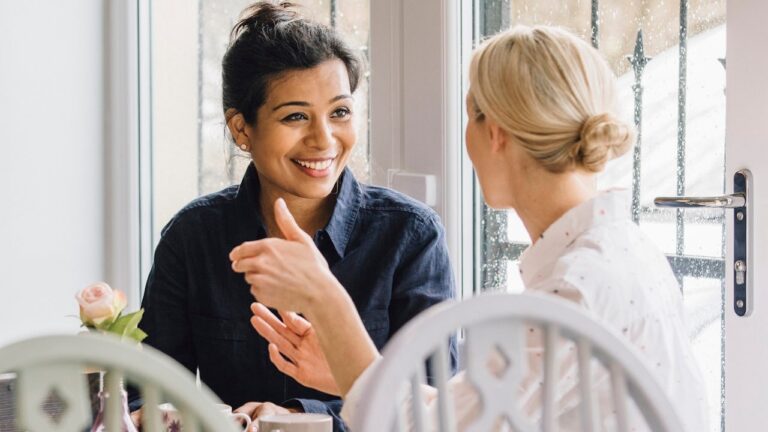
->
[474,0,725,292]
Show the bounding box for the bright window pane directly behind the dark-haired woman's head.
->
[152,0,369,241]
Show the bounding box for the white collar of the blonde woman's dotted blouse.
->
[519,189,629,286]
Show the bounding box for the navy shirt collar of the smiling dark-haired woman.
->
[236,163,363,257]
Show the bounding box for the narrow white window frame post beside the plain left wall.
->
[104,0,152,309]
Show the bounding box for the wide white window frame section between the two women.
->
[370,0,474,295]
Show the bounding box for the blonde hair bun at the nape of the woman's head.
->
[574,113,635,172]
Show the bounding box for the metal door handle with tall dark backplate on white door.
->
[653,169,754,316]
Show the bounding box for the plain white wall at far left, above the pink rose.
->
[0,0,105,346]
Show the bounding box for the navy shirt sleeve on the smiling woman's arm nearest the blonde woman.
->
[389,214,458,372]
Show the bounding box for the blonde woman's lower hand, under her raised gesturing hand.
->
[251,303,341,396]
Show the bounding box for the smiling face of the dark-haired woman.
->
[246,60,357,199]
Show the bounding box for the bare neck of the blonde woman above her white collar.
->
[515,169,597,243]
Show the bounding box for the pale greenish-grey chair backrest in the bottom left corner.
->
[0,334,238,432]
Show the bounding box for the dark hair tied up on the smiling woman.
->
[221,1,362,124]
